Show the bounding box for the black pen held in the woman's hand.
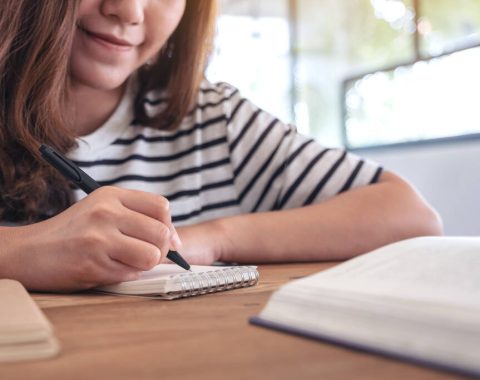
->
[40,145,190,270]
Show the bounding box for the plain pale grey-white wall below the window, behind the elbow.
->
[358,139,480,236]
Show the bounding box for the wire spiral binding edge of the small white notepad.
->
[174,267,259,297]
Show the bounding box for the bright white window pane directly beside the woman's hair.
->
[207,0,294,122]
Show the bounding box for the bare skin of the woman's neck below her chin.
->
[67,83,125,136]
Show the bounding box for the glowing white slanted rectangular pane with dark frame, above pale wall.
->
[344,46,480,148]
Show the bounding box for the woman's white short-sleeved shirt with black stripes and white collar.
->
[69,81,381,225]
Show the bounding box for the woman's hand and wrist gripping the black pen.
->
[0,186,181,291]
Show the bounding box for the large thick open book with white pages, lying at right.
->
[251,237,480,376]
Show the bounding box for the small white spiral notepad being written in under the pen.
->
[95,264,259,300]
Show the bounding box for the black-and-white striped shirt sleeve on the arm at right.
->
[221,84,382,212]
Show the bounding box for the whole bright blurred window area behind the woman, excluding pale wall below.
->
[208,0,480,147]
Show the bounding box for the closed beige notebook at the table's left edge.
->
[0,280,59,362]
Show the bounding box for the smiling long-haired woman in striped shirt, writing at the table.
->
[0,0,441,291]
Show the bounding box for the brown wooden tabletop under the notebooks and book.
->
[0,263,459,380]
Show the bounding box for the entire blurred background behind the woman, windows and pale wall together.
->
[207,0,480,235]
